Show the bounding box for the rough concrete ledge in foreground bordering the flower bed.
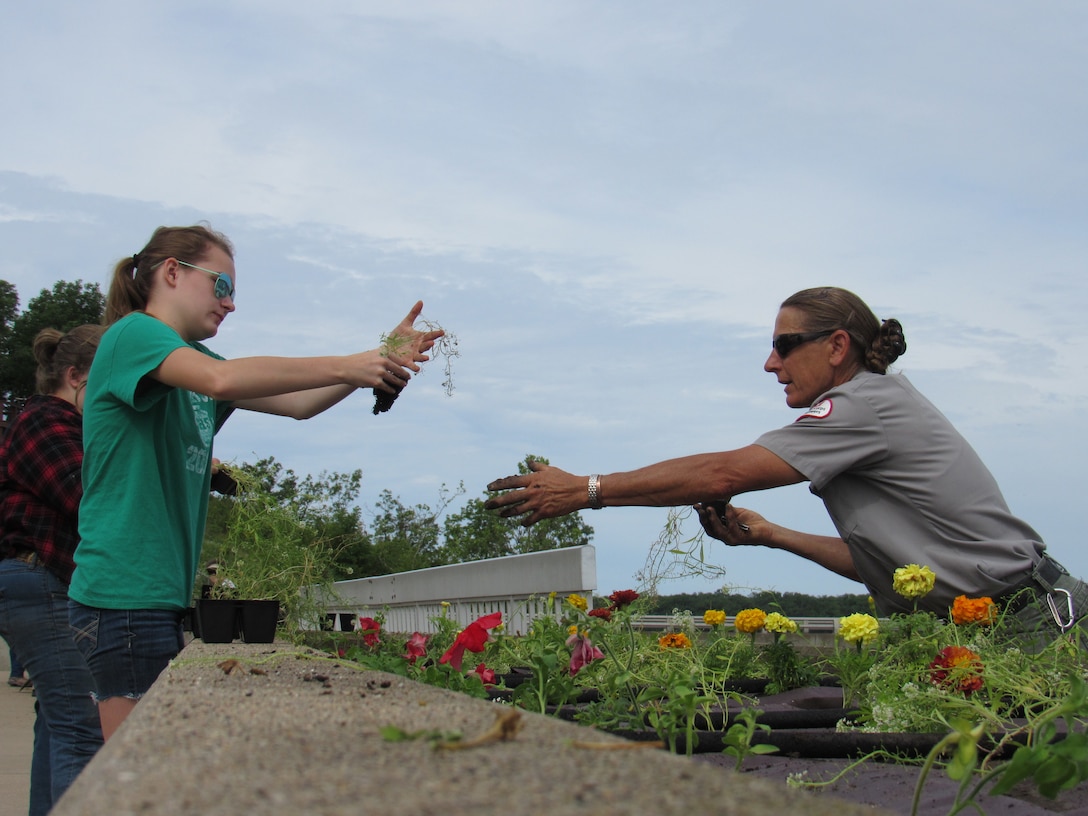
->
[52,641,873,816]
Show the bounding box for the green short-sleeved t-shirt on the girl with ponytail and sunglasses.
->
[69,312,232,609]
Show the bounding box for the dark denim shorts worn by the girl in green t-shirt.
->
[69,601,185,702]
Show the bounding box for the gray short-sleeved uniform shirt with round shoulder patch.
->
[755,371,1044,615]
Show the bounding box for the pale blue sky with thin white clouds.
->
[0,0,1088,594]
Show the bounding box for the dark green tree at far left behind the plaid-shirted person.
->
[0,281,106,401]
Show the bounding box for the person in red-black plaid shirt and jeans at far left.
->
[0,325,104,816]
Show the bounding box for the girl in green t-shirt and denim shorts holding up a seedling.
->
[69,225,443,739]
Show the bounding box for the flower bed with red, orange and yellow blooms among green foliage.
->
[317,565,1088,802]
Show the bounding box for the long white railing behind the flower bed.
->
[326,544,597,634]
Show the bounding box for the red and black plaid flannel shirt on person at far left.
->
[0,395,83,583]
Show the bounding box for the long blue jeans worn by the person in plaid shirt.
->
[0,558,102,816]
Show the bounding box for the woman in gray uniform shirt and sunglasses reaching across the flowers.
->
[486,287,1088,632]
